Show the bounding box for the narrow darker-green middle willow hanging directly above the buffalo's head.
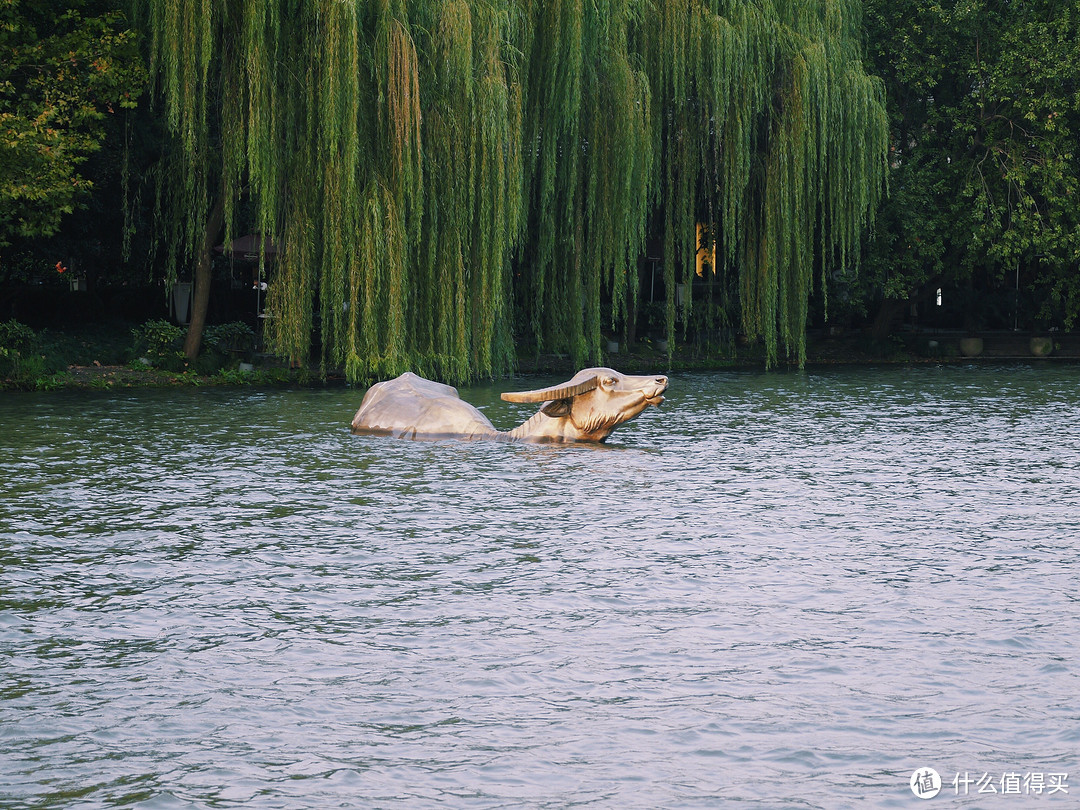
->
[509,0,657,363]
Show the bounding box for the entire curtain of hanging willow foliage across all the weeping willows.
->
[144,0,886,380]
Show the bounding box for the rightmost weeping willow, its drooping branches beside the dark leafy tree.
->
[637,0,888,365]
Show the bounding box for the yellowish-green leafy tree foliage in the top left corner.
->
[0,0,146,245]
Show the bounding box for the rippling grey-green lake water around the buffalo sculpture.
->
[0,365,1080,808]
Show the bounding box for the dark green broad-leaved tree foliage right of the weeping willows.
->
[861,0,1080,327]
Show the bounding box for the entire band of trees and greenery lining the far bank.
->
[0,0,1080,387]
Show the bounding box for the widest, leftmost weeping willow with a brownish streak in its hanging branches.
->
[144,0,522,379]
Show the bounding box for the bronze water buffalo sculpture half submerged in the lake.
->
[352,368,667,442]
